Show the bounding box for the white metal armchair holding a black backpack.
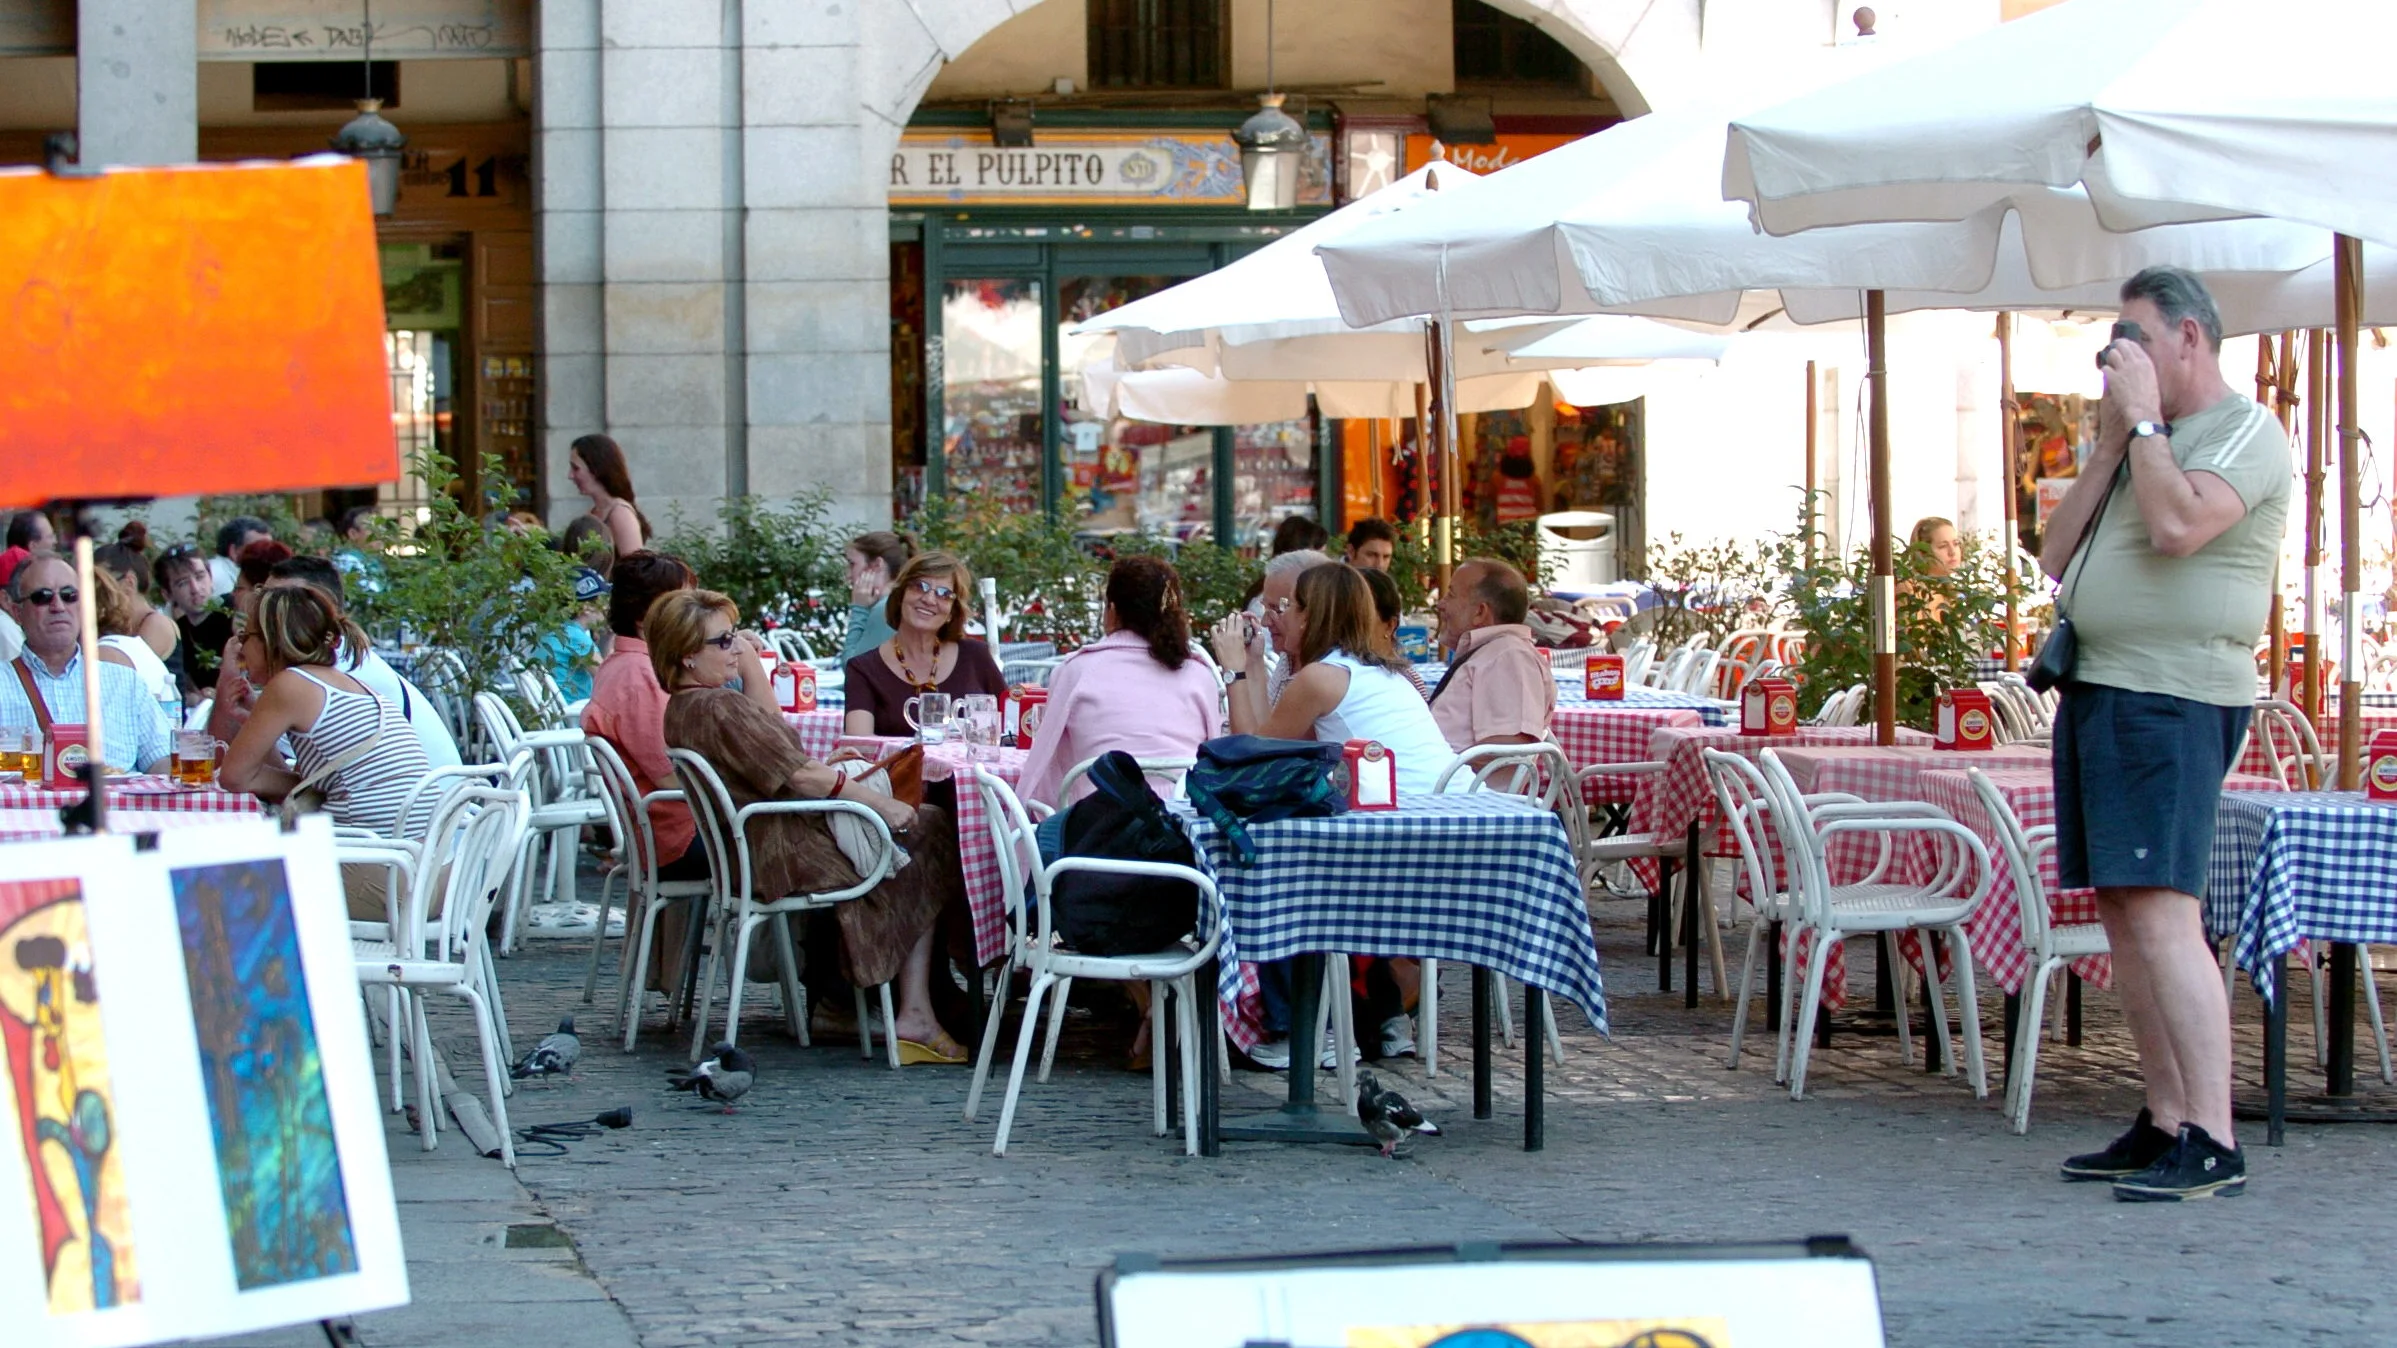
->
[966,768,1217,1156]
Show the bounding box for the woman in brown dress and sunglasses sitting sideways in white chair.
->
[642,590,966,1063]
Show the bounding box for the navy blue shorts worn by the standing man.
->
[2054,684,2253,899]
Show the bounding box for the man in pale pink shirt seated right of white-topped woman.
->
[1431,556,1556,751]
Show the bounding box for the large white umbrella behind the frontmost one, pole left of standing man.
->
[1318,108,2358,744]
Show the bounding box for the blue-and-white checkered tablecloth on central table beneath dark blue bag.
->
[1175,792,1606,1034]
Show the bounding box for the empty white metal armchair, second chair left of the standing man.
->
[1757,748,1990,1099]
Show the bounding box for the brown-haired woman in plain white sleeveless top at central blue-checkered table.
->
[1213,551,1455,799]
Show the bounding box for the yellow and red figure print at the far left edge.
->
[0,880,141,1314]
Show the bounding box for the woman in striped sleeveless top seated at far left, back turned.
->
[218,585,434,921]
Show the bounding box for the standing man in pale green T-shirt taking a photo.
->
[2040,266,2289,1202]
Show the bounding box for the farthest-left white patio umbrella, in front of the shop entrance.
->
[1071,163,1726,571]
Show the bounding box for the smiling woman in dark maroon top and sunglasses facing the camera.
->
[841,552,1007,736]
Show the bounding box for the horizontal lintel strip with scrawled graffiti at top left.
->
[199,0,532,60]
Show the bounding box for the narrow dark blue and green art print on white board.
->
[173,856,357,1290]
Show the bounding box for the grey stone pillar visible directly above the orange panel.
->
[74,0,199,166]
